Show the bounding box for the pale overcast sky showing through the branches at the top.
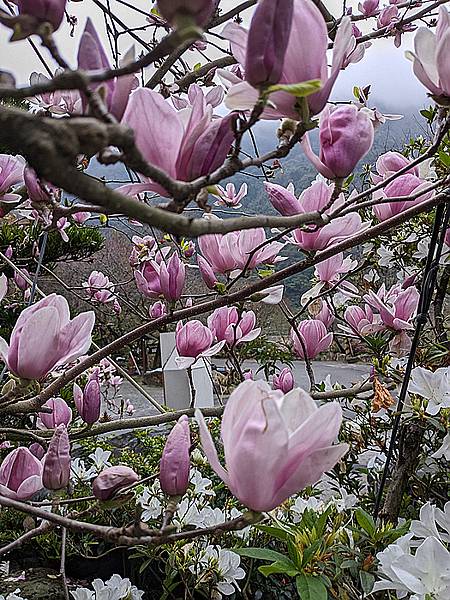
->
[0,0,427,112]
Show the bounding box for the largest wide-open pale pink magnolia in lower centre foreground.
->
[196,381,348,512]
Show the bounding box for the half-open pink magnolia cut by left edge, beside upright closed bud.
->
[0,446,42,500]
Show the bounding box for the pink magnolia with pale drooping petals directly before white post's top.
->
[175,319,225,369]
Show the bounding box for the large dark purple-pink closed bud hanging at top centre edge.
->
[245,0,294,87]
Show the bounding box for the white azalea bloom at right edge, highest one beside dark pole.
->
[408,367,450,415]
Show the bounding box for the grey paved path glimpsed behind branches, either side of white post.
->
[117,359,370,417]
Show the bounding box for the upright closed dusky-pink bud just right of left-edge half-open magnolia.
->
[42,425,71,490]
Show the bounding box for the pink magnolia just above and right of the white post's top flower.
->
[208,306,261,346]
